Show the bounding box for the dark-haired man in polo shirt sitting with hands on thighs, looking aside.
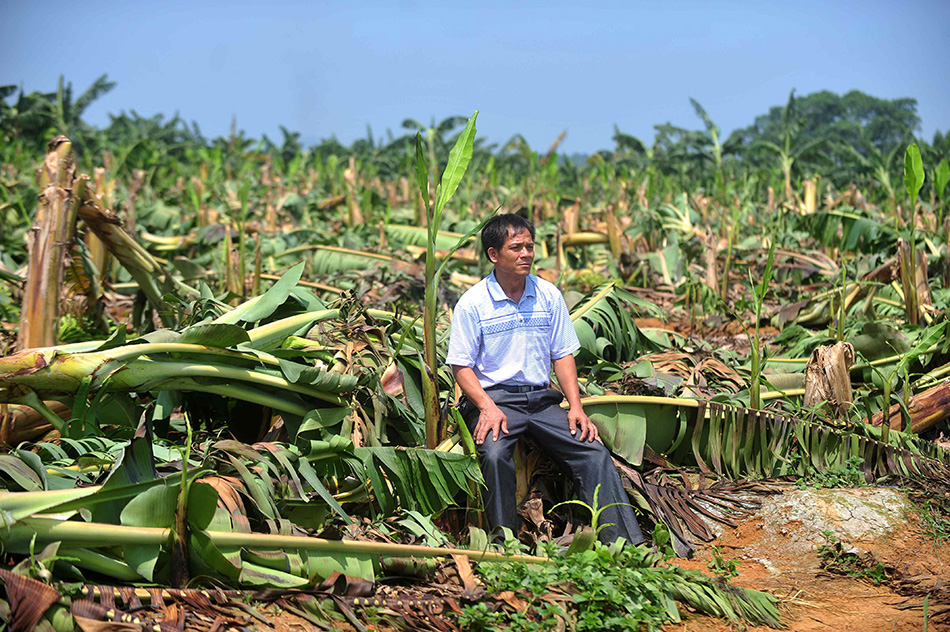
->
[446,215,643,544]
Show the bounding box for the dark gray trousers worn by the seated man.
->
[459,388,643,544]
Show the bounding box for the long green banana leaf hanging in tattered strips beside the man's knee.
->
[583,396,950,483]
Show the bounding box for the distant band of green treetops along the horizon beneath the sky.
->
[0,75,950,201]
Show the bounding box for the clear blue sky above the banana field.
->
[0,0,950,153]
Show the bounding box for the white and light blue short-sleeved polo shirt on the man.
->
[445,272,580,388]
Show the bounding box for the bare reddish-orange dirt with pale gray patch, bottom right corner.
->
[664,487,950,632]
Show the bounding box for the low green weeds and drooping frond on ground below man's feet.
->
[458,543,779,632]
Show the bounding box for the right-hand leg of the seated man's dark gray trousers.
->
[525,389,643,544]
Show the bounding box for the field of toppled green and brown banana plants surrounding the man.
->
[0,77,950,632]
